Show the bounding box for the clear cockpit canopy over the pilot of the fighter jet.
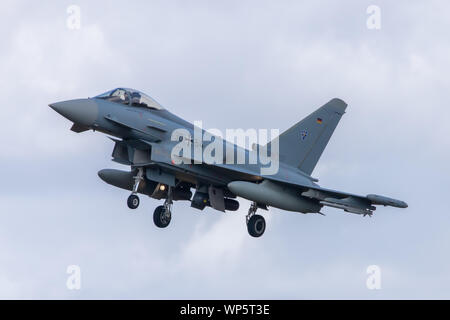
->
[95,88,164,110]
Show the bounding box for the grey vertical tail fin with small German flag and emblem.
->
[268,98,347,174]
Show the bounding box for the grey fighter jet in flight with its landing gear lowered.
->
[49,88,408,237]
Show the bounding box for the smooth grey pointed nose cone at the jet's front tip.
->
[49,99,98,126]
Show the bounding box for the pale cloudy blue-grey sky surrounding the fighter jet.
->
[0,0,450,299]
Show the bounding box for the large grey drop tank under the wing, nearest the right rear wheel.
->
[228,180,322,213]
